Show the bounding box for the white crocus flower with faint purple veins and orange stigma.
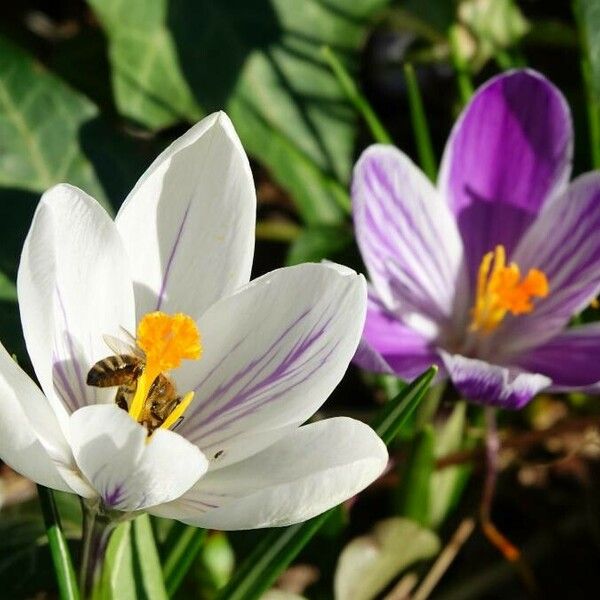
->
[0,113,387,530]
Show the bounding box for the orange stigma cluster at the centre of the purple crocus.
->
[470,245,550,333]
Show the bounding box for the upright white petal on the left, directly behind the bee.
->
[17,184,135,425]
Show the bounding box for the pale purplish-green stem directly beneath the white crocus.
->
[79,499,118,599]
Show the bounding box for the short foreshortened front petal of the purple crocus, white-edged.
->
[440,351,552,409]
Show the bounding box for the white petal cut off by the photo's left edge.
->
[0,344,72,492]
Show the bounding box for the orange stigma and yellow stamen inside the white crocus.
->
[129,311,202,429]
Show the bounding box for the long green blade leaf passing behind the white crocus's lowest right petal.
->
[218,367,437,600]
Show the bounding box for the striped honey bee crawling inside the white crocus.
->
[86,334,181,435]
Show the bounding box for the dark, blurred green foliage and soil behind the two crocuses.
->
[0,0,600,600]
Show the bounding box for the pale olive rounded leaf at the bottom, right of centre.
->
[334,517,440,600]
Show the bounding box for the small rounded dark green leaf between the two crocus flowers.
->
[286,225,354,265]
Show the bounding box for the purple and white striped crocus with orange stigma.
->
[352,70,600,408]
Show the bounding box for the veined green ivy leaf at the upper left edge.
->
[0,37,104,200]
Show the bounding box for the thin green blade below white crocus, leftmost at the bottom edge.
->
[37,485,79,600]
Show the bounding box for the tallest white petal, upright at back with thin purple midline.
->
[116,113,256,319]
